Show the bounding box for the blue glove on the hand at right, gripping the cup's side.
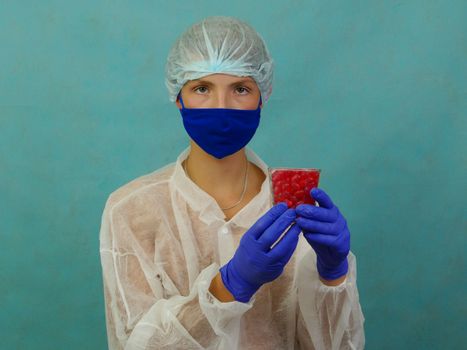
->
[296,188,350,280]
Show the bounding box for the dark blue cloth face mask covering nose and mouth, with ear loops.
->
[179,94,262,159]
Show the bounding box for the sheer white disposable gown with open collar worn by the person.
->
[100,147,365,350]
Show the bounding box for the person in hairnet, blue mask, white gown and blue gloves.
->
[100,16,365,349]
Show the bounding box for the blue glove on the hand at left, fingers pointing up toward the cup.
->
[220,203,301,302]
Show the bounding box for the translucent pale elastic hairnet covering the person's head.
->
[165,16,274,102]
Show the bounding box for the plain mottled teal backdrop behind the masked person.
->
[0,0,467,350]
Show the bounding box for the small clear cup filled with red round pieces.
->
[268,168,321,208]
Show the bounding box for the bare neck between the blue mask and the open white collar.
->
[185,141,247,201]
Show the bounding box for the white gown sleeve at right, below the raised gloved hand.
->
[295,249,365,350]
